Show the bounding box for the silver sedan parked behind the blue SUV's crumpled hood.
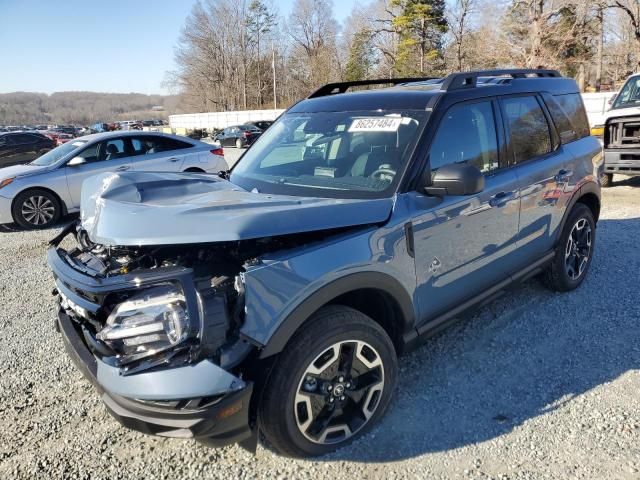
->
[0,132,228,229]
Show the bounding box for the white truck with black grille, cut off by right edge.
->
[592,74,640,187]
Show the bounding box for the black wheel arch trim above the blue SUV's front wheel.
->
[260,272,417,358]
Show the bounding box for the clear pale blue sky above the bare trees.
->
[0,0,362,94]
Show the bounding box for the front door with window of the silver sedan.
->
[65,138,131,209]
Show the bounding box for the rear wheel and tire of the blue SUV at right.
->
[546,203,596,292]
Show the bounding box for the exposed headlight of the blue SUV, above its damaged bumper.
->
[97,285,194,361]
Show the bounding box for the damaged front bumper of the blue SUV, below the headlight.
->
[57,310,253,446]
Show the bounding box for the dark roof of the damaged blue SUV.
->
[288,75,580,113]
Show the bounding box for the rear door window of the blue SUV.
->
[502,97,551,164]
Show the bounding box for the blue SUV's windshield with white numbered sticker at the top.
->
[231,110,427,198]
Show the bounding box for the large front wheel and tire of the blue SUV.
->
[258,305,398,457]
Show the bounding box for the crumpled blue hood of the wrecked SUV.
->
[80,172,393,246]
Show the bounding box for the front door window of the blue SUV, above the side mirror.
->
[429,101,499,172]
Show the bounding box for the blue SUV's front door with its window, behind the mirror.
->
[408,100,520,329]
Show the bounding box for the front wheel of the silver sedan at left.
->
[11,189,62,230]
